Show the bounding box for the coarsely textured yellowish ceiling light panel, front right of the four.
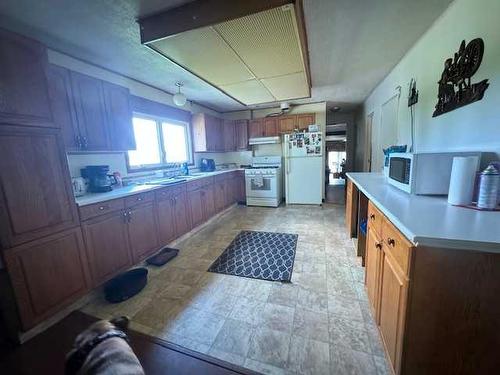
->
[214,5,304,78]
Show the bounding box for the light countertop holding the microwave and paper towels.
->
[347,173,500,252]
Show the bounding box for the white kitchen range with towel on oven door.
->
[245,156,283,207]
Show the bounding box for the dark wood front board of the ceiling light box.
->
[137,0,293,44]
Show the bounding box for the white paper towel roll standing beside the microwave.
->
[448,156,479,205]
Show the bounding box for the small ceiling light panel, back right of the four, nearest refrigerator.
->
[262,72,309,100]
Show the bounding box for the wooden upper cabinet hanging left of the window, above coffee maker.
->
[47,65,136,151]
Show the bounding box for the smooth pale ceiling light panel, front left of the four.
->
[152,27,255,85]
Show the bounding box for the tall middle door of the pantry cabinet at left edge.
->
[0,126,79,248]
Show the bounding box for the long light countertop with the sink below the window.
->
[75,168,244,207]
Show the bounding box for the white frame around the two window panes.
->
[125,112,194,173]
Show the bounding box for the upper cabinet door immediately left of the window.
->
[103,82,136,151]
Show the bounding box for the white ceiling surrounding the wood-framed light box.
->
[0,0,452,112]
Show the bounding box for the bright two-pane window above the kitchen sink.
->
[128,115,192,169]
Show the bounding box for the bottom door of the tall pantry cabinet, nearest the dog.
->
[4,227,90,330]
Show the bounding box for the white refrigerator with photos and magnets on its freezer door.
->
[283,132,324,204]
